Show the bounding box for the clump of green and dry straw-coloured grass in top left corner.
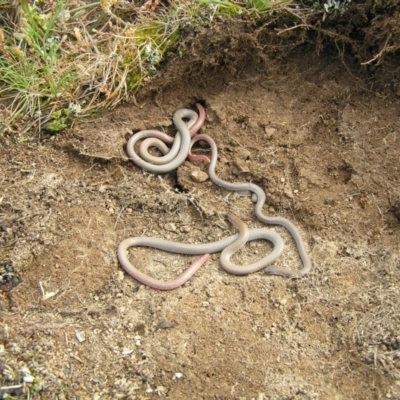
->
[0,0,193,133]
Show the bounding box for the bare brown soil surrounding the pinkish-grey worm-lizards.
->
[0,19,400,400]
